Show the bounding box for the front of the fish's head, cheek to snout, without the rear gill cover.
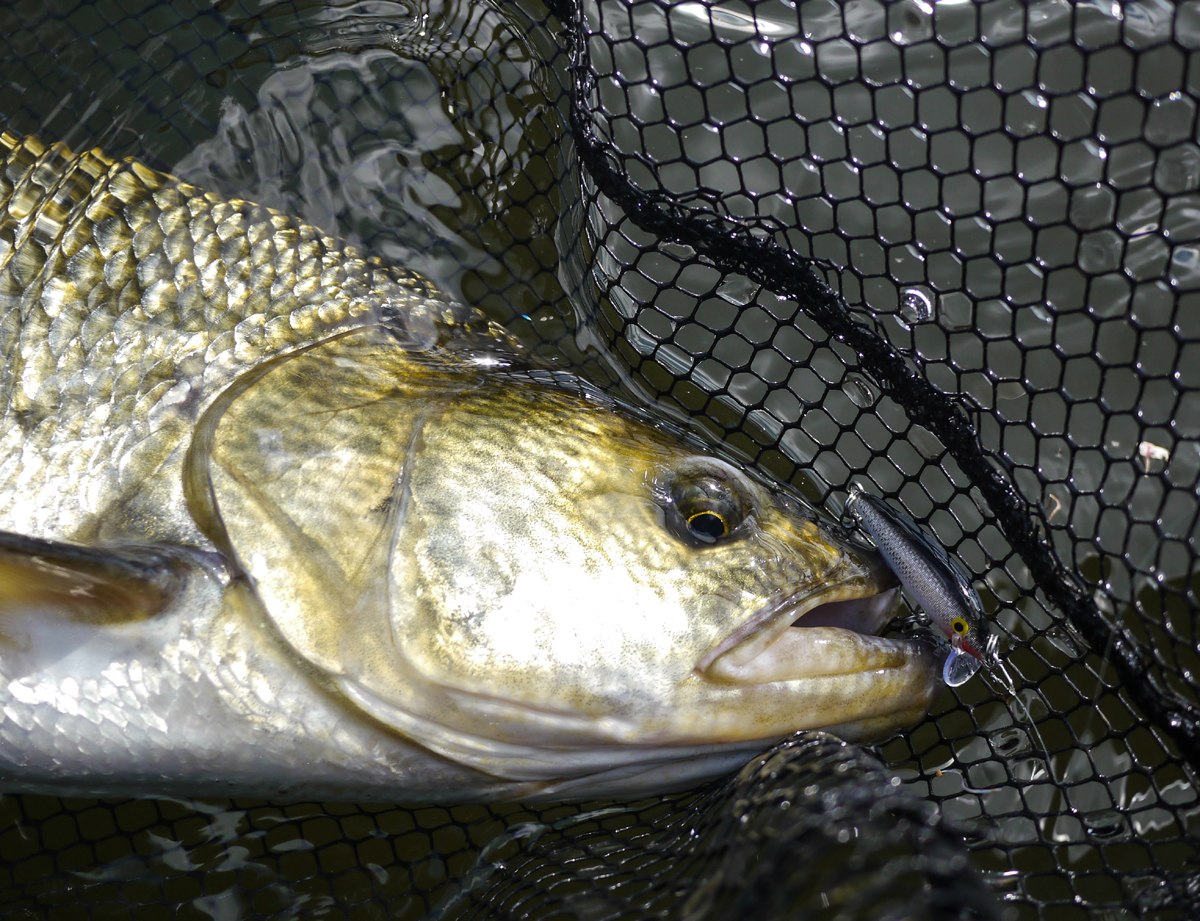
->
[392,385,930,745]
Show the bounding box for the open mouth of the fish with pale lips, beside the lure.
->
[695,570,929,685]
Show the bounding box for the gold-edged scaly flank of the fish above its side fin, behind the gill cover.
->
[0,133,508,541]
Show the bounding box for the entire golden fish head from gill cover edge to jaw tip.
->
[201,335,940,795]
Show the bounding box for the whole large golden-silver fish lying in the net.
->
[0,132,941,805]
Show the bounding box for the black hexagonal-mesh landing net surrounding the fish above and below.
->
[0,0,1200,920]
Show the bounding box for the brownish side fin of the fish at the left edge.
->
[0,531,186,623]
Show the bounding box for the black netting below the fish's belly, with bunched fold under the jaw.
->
[0,736,1000,921]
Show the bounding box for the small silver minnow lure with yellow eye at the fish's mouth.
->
[846,483,997,687]
